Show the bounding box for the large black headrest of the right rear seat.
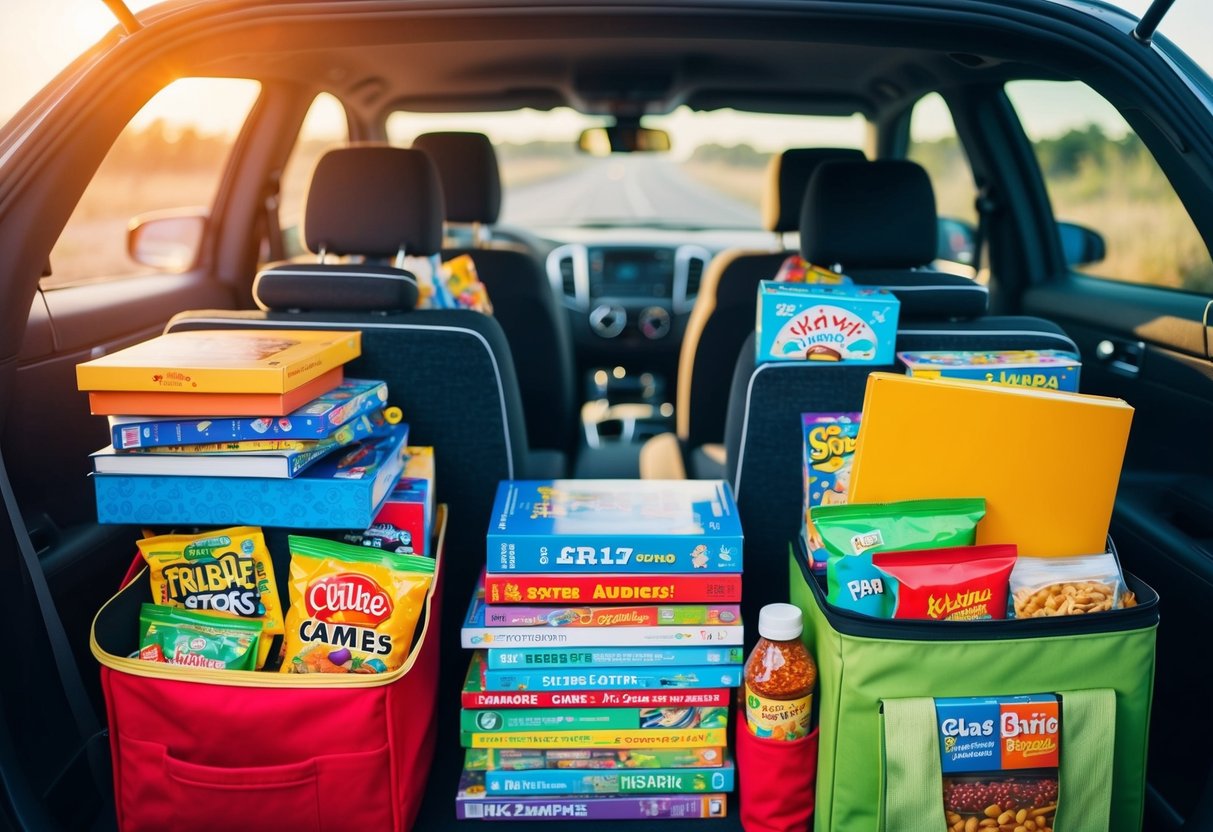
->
[801,159,938,266]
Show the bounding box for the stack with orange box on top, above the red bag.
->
[76,330,409,529]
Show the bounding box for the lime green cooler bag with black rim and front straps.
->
[790,549,1158,832]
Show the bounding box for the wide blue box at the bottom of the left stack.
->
[92,424,409,529]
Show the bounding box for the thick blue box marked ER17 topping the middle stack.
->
[488,479,741,575]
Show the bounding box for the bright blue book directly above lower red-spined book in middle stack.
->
[483,669,742,690]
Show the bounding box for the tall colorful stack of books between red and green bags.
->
[456,480,745,820]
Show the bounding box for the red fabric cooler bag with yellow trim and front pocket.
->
[91,508,446,832]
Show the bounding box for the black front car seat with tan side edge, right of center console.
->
[645,148,864,478]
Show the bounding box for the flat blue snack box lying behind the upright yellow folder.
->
[898,349,1082,393]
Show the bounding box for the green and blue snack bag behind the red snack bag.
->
[811,497,985,619]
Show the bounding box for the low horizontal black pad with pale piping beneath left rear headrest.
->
[252,263,417,312]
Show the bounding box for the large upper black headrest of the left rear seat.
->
[303,146,443,257]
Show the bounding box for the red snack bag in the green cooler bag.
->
[872,543,1016,621]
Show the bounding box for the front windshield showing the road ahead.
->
[387,108,867,229]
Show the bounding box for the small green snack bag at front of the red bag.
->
[139,604,261,671]
